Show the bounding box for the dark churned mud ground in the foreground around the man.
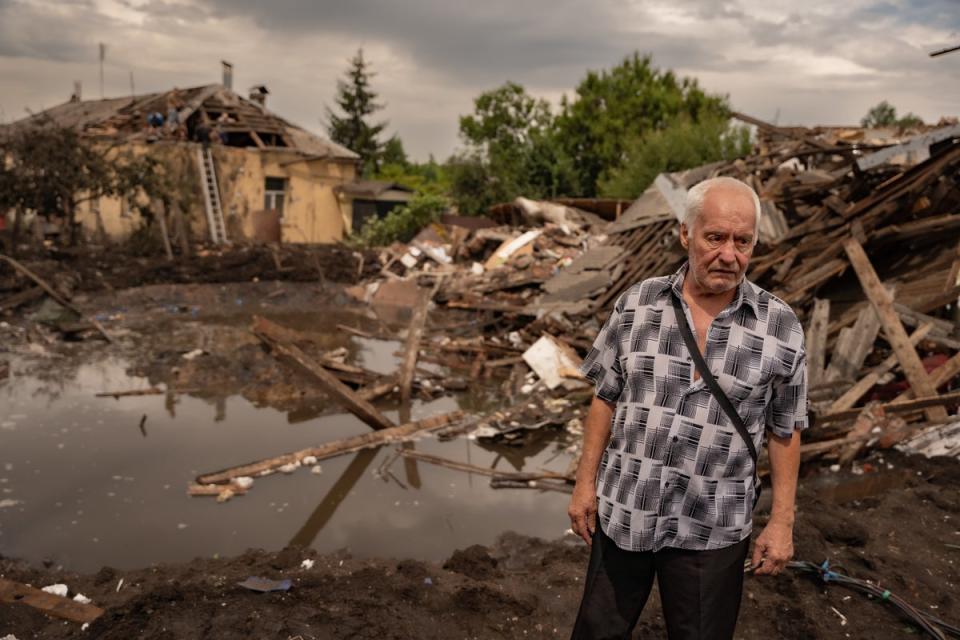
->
[0,452,960,640]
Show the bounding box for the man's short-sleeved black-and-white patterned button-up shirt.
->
[580,264,807,551]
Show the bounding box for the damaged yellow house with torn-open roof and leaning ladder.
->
[10,78,376,244]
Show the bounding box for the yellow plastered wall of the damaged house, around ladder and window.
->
[77,143,356,243]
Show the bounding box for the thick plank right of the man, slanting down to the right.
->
[843,237,947,420]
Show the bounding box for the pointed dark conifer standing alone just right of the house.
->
[326,49,387,175]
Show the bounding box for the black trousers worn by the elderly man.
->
[573,522,750,640]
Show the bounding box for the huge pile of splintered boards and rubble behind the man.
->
[332,114,960,470]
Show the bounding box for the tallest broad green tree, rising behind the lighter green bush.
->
[556,53,727,197]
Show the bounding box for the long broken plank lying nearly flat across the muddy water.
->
[196,411,464,485]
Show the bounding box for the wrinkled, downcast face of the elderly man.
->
[680,185,756,293]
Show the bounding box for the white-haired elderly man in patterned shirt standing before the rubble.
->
[569,178,807,640]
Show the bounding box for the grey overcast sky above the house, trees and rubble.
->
[0,0,960,159]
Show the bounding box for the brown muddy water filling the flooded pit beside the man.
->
[0,339,569,571]
